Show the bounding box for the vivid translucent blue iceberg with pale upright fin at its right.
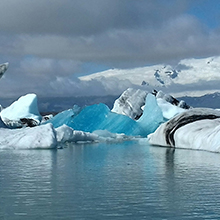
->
[46,94,164,137]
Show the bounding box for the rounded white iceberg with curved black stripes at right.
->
[148,108,220,152]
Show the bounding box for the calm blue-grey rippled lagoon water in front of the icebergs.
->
[0,140,220,220]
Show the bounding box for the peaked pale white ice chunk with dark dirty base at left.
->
[0,94,42,128]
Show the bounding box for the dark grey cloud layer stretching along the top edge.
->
[0,0,189,36]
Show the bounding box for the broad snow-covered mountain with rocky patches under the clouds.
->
[79,56,220,96]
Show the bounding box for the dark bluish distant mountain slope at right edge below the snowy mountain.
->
[178,92,220,109]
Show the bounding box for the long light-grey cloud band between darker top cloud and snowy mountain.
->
[11,15,220,68]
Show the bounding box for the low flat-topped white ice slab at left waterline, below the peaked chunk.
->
[0,124,57,149]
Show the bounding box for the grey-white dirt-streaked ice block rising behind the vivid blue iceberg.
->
[112,88,147,119]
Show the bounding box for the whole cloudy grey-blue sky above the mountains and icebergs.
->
[0,0,220,97]
